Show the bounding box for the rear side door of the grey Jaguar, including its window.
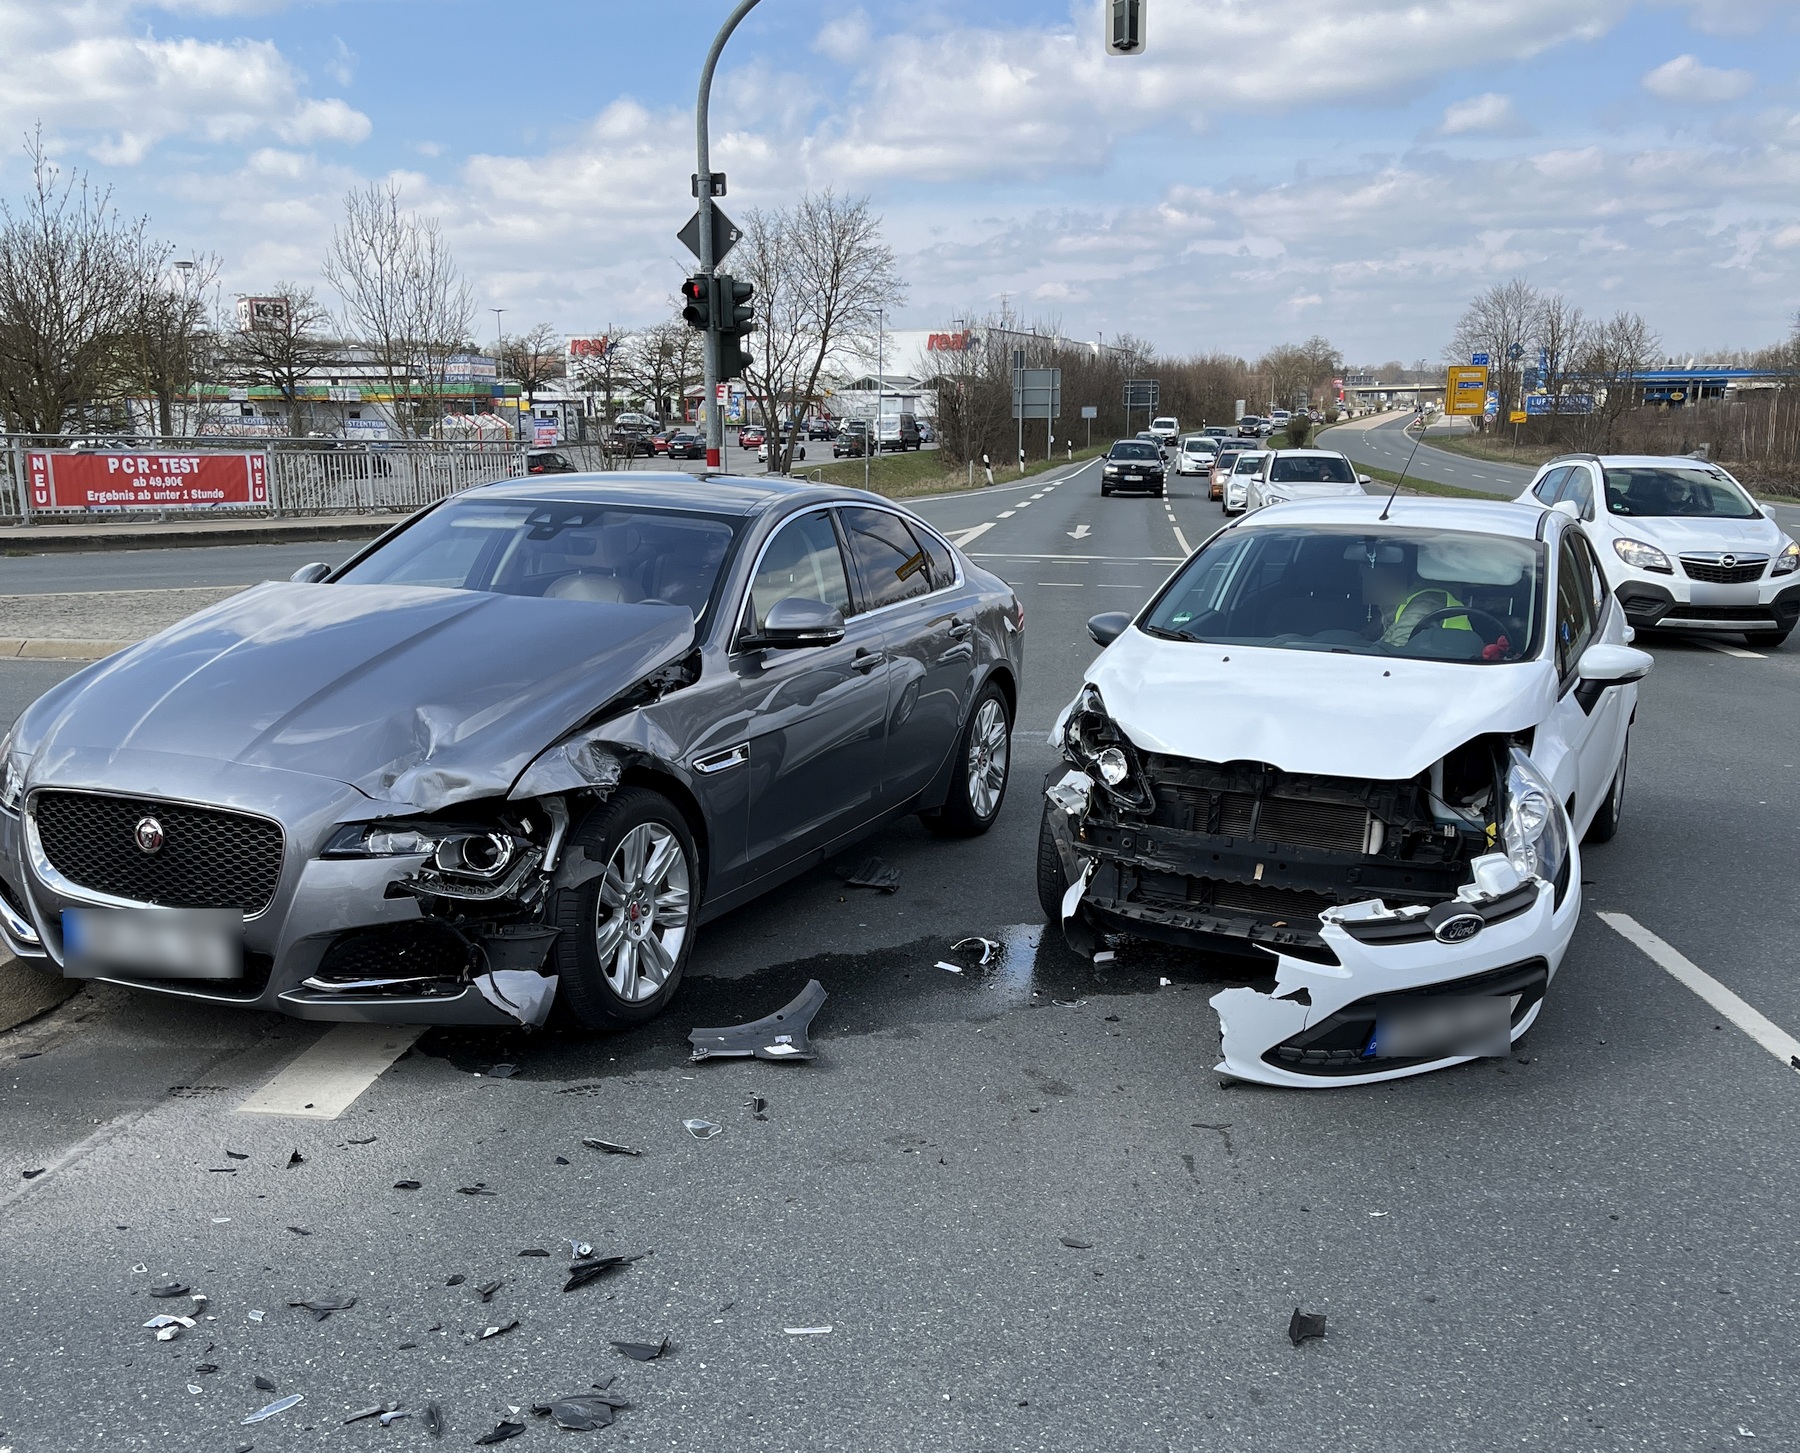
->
[837,506,976,808]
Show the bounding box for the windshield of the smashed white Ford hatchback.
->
[1143,526,1544,664]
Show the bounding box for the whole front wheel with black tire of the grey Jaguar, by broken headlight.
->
[554,787,700,1030]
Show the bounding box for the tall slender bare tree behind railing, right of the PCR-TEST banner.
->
[324,182,475,438]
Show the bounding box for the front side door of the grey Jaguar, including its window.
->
[731,510,891,880]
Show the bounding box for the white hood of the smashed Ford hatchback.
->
[1087,627,1557,781]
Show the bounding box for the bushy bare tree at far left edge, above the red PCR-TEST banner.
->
[0,135,153,434]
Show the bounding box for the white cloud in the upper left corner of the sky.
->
[0,0,369,166]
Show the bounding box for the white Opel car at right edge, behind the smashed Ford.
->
[1519,454,1800,650]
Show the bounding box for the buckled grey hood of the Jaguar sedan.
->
[20,583,693,808]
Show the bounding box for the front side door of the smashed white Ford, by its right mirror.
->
[1532,529,1622,834]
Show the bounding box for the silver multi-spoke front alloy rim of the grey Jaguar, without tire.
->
[594,823,691,1005]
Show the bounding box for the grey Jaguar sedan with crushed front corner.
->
[0,474,1024,1028]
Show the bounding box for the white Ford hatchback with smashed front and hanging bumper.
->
[1037,497,1654,1089]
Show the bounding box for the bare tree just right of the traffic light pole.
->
[734,191,905,474]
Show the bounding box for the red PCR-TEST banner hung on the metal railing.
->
[25,450,268,510]
